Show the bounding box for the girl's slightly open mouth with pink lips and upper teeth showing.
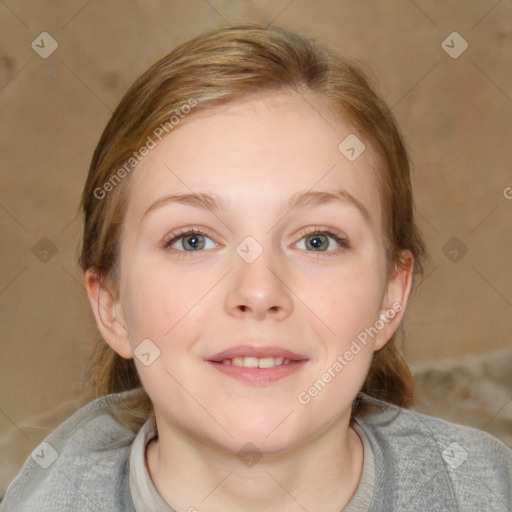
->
[207,346,309,384]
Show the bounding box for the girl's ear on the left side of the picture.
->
[85,269,133,359]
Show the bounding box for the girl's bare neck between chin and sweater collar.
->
[147,417,363,512]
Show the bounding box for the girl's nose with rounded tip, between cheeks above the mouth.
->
[225,244,293,320]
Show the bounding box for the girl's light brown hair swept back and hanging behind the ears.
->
[79,24,426,430]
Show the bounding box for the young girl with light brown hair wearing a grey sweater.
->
[2,25,512,512]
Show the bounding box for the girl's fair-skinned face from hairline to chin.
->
[87,93,409,453]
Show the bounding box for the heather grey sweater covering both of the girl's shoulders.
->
[0,394,512,512]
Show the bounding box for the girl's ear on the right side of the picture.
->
[374,251,414,350]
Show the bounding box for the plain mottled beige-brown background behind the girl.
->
[0,0,512,495]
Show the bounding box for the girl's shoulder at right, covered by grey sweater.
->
[357,395,512,511]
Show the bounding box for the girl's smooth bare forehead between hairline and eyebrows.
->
[127,92,381,228]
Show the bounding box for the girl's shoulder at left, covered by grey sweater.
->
[0,393,139,512]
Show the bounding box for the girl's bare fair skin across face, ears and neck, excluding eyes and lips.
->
[85,92,413,511]
